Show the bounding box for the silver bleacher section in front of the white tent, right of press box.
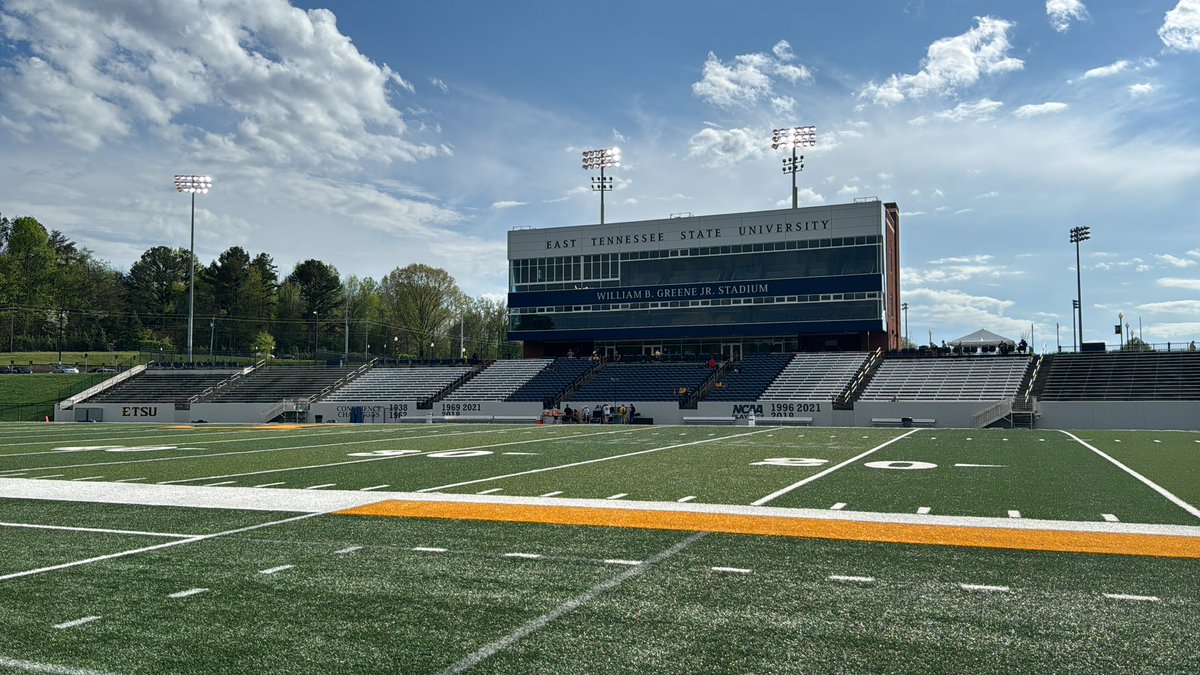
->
[858,354,1031,401]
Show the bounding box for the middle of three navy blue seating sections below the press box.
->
[571,363,713,402]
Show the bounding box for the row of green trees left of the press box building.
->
[0,215,520,360]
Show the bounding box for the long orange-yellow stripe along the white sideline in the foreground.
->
[337,500,1200,558]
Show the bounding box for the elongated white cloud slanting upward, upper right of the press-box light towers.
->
[858,17,1025,106]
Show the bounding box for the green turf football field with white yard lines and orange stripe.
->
[0,424,1200,673]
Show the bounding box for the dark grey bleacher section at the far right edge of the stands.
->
[1034,352,1200,401]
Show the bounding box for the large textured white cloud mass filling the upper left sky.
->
[0,0,440,169]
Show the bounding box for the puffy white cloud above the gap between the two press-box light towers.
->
[691,40,812,108]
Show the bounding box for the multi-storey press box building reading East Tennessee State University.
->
[508,199,900,358]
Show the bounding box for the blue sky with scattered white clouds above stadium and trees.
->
[0,0,1200,348]
